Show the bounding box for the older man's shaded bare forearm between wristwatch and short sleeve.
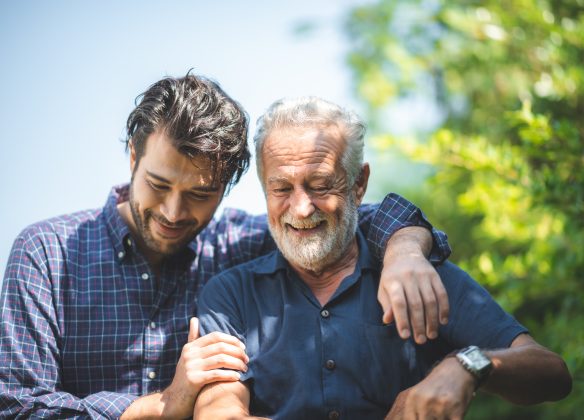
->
[483,335,572,405]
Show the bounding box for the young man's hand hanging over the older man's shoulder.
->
[377,227,449,344]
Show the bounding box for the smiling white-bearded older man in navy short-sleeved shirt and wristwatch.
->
[195,98,571,419]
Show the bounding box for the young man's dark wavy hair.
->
[125,71,250,192]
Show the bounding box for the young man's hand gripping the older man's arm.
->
[162,318,249,418]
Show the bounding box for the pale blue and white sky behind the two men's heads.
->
[0,0,378,273]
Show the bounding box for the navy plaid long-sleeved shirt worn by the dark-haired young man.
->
[0,185,450,418]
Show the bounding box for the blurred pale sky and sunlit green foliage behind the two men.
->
[0,0,584,419]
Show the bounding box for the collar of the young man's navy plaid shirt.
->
[103,183,197,263]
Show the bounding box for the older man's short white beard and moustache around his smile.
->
[269,197,359,273]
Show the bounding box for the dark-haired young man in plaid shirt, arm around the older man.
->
[0,75,448,418]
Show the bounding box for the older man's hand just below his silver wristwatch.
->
[385,357,475,420]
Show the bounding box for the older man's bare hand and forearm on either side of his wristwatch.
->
[386,334,572,420]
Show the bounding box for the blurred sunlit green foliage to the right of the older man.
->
[347,0,584,419]
